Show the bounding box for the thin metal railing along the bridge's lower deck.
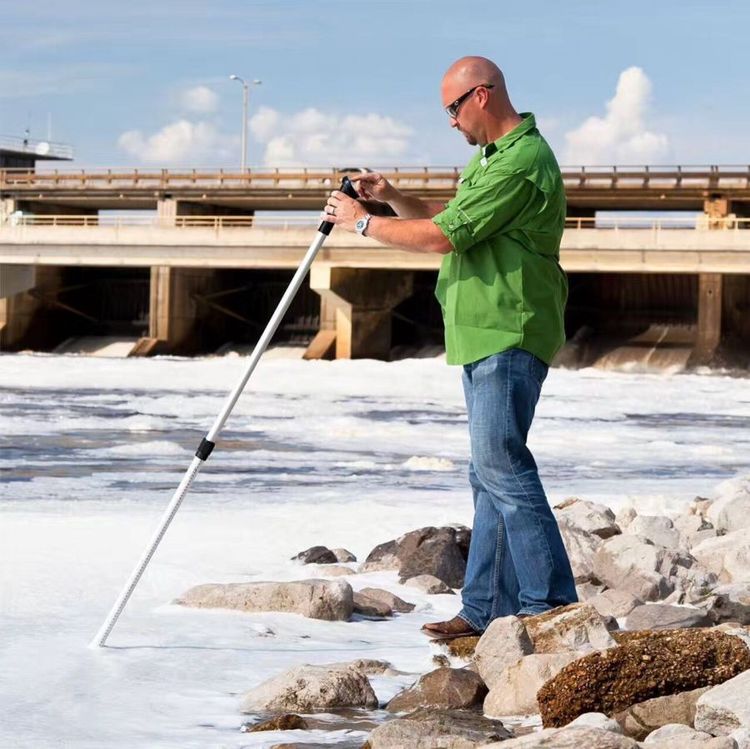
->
[0,213,750,232]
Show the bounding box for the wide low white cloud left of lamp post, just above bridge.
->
[117,119,238,166]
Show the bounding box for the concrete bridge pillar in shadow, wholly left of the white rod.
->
[131,265,216,356]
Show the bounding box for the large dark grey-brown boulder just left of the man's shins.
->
[360,526,471,588]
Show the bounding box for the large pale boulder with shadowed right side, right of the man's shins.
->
[593,535,677,601]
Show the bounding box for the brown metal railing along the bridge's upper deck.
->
[0,165,750,191]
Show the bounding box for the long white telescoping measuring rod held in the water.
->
[89,178,357,648]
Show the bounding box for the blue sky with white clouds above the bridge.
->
[0,0,750,168]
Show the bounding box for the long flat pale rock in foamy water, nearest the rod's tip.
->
[175,580,354,621]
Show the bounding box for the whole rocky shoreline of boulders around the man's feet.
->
[176,478,750,749]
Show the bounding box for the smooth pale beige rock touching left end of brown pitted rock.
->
[484,652,578,717]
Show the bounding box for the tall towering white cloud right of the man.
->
[564,67,670,165]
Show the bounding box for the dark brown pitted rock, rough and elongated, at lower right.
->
[536,629,750,726]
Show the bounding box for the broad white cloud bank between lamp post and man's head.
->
[250,107,413,166]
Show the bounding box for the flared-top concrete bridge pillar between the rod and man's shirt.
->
[310,265,414,359]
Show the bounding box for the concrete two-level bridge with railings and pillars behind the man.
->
[0,166,750,362]
